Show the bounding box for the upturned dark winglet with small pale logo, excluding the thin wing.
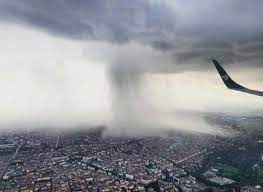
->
[212,59,244,90]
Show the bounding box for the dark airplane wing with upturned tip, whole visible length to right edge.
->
[212,59,263,97]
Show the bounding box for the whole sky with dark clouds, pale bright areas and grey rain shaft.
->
[0,0,263,134]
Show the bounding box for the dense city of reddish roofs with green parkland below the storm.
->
[0,114,263,192]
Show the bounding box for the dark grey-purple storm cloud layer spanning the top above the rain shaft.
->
[0,0,263,70]
